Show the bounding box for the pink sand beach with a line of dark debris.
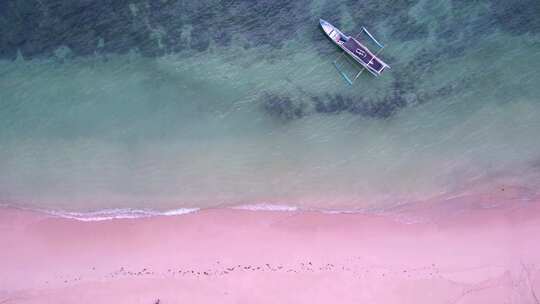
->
[0,202,540,304]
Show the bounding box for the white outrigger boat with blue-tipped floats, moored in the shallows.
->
[319,19,390,85]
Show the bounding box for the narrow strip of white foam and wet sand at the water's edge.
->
[0,185,540,223]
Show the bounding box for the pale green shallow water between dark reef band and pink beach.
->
[0,28,540,210]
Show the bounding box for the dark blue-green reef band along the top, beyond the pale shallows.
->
[0,0,540,59]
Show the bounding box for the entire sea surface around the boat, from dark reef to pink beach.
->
[0,0,540,214]
